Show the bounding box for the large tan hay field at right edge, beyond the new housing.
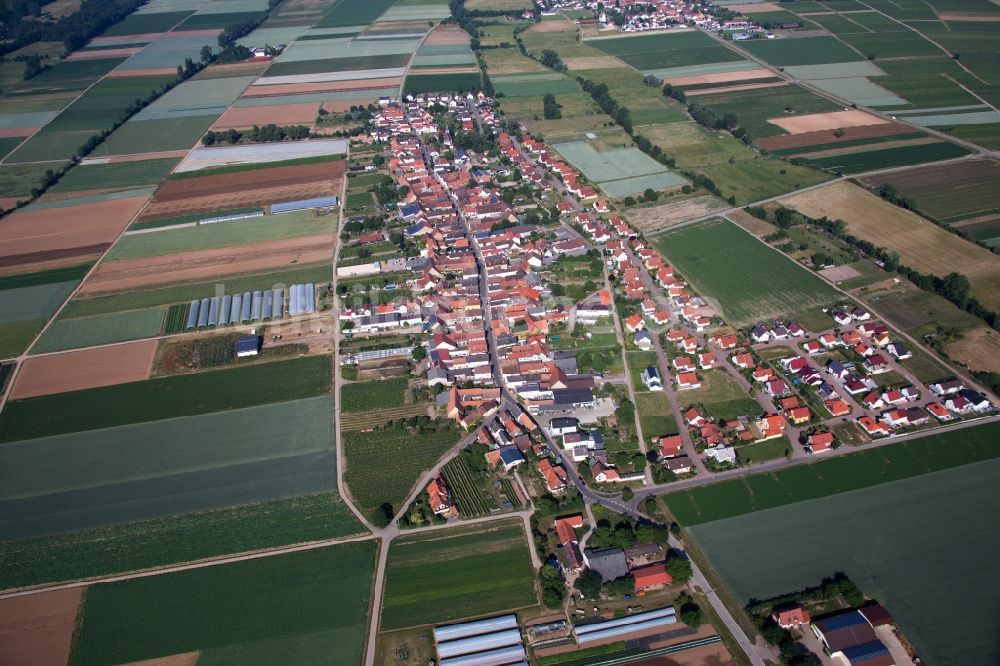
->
[782,182,1000,311]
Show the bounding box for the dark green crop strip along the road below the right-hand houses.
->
[665,423,1000,526]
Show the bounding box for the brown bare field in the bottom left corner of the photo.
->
[0,587,83,666]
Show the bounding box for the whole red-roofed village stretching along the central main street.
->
[337,93,994,640]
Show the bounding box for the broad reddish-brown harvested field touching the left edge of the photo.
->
[0,197,147,266]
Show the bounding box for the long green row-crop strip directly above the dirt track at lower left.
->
[0,492,364,589]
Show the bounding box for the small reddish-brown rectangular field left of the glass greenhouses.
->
[10,340,157,400]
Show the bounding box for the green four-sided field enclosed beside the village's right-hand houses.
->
[656,220,837,330]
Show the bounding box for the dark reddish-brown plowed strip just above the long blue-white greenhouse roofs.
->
[142,159,344,220]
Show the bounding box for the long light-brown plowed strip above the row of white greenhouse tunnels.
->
[80,234,333,295]
